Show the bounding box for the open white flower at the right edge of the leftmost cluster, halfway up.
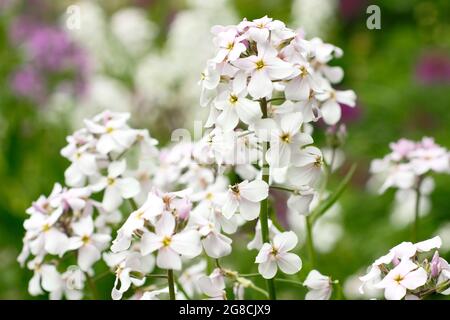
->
[92,160,140,211]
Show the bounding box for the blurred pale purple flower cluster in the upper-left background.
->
[9,16,88,103]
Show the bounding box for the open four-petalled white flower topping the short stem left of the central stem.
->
[141,213,202,270]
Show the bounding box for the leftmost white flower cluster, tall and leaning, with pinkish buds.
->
[18,111,157,299]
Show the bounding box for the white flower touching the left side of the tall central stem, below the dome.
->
[222,180,269,220]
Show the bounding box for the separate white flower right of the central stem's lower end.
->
[255,231,302,279]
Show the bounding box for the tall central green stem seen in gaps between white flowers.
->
[259,98,276,300]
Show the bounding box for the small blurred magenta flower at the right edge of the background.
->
[416,52,450,85]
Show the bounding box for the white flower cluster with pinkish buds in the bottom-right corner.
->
[360,237,450,300]
